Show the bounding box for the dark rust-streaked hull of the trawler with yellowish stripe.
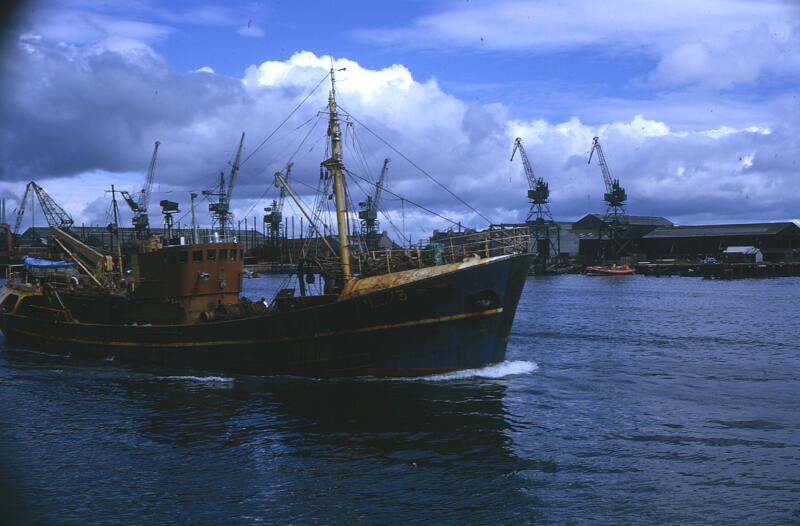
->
[2,255,530,377]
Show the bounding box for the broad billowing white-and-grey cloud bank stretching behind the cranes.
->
[0,35,800,238]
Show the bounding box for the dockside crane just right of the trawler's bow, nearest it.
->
[509,137,561,266]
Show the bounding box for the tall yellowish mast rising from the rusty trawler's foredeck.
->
[322,61,353,283]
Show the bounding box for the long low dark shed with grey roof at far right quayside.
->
[641,222,800,261]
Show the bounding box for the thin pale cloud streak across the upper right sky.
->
[356,0,800,88]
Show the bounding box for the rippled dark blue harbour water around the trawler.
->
[0,276,800,525]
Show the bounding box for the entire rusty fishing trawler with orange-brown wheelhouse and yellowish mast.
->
[0,69,530,377]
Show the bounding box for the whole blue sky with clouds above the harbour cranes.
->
[0,0,800,240]
